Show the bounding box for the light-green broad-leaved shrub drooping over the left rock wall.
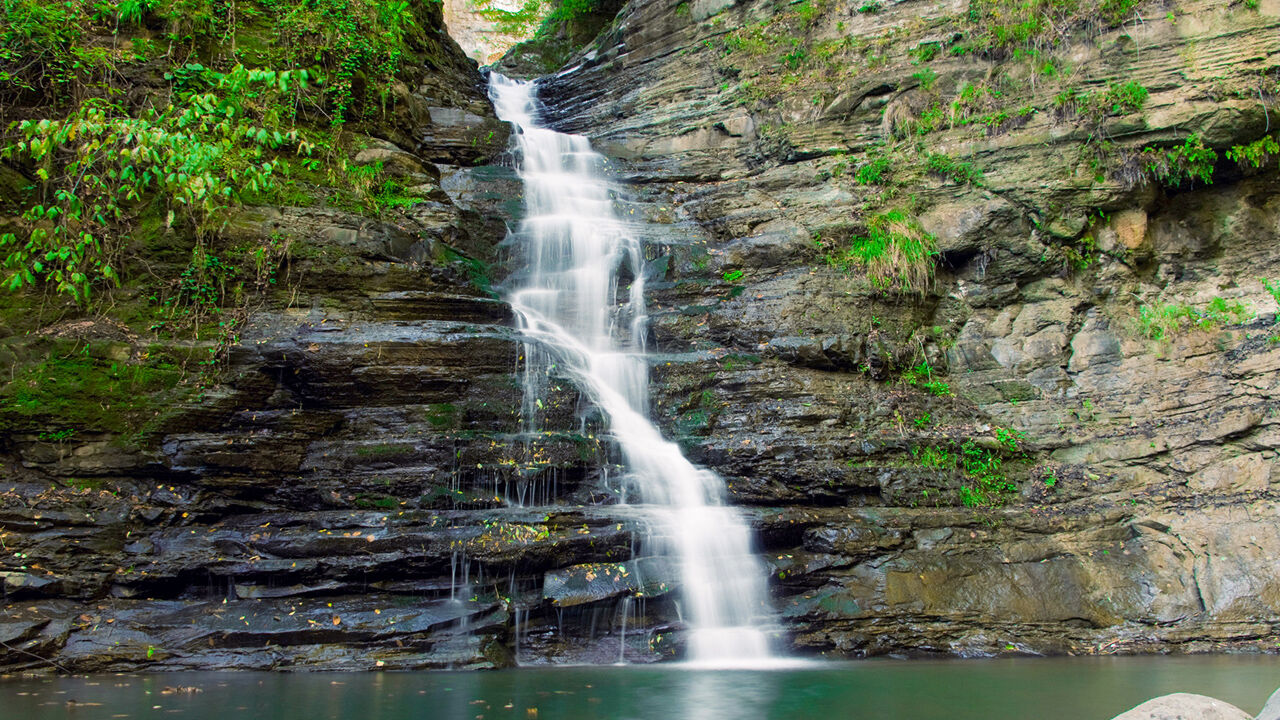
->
[0,65,307,304]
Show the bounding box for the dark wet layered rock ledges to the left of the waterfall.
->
[0,4,629,671]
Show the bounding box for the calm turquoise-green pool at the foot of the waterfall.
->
[0,656,1280,720]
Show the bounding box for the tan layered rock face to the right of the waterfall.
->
[532,1,1280,656]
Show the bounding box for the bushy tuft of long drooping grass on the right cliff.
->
[827,209,937,293]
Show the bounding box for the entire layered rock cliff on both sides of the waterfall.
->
[0,0,1280,671]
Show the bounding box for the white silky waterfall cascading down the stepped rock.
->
[489,73,771,666]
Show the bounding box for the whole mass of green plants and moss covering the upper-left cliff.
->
[0,0,479,430]
